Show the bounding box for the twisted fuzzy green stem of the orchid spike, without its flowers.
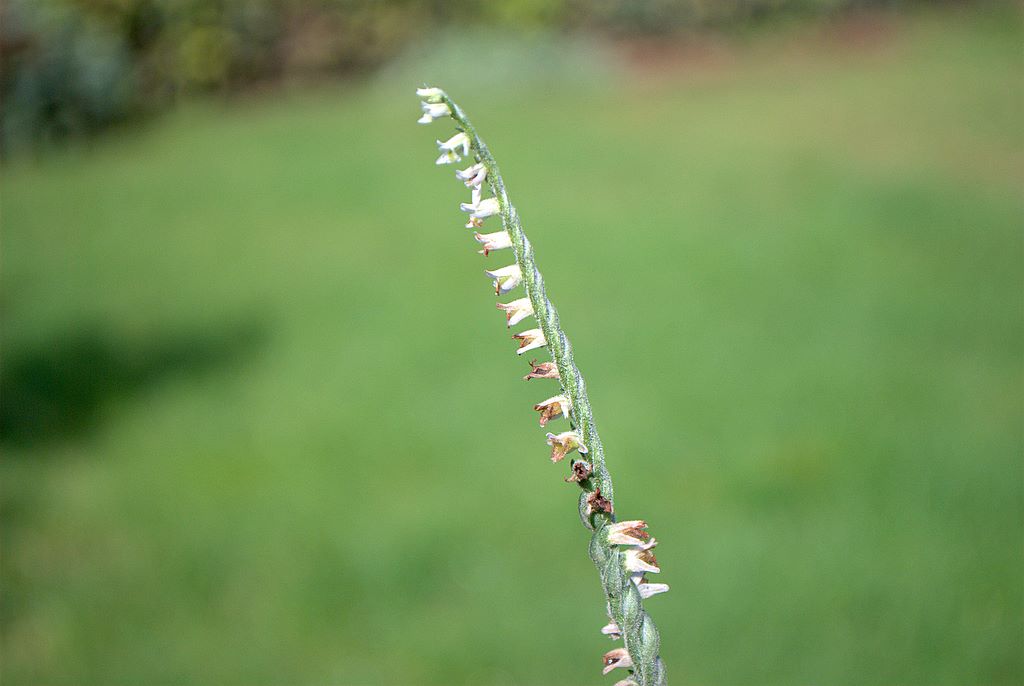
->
[441,93,666,686]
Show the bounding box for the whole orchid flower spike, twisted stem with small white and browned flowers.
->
[416,88,669,686]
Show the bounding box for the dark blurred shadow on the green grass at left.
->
[0,319,266,445]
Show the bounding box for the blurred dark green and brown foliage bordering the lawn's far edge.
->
[0,0,942,153]
